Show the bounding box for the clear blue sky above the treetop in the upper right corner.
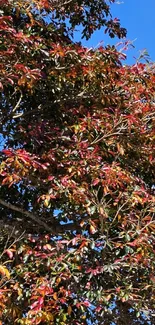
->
[76,0,155,64]
